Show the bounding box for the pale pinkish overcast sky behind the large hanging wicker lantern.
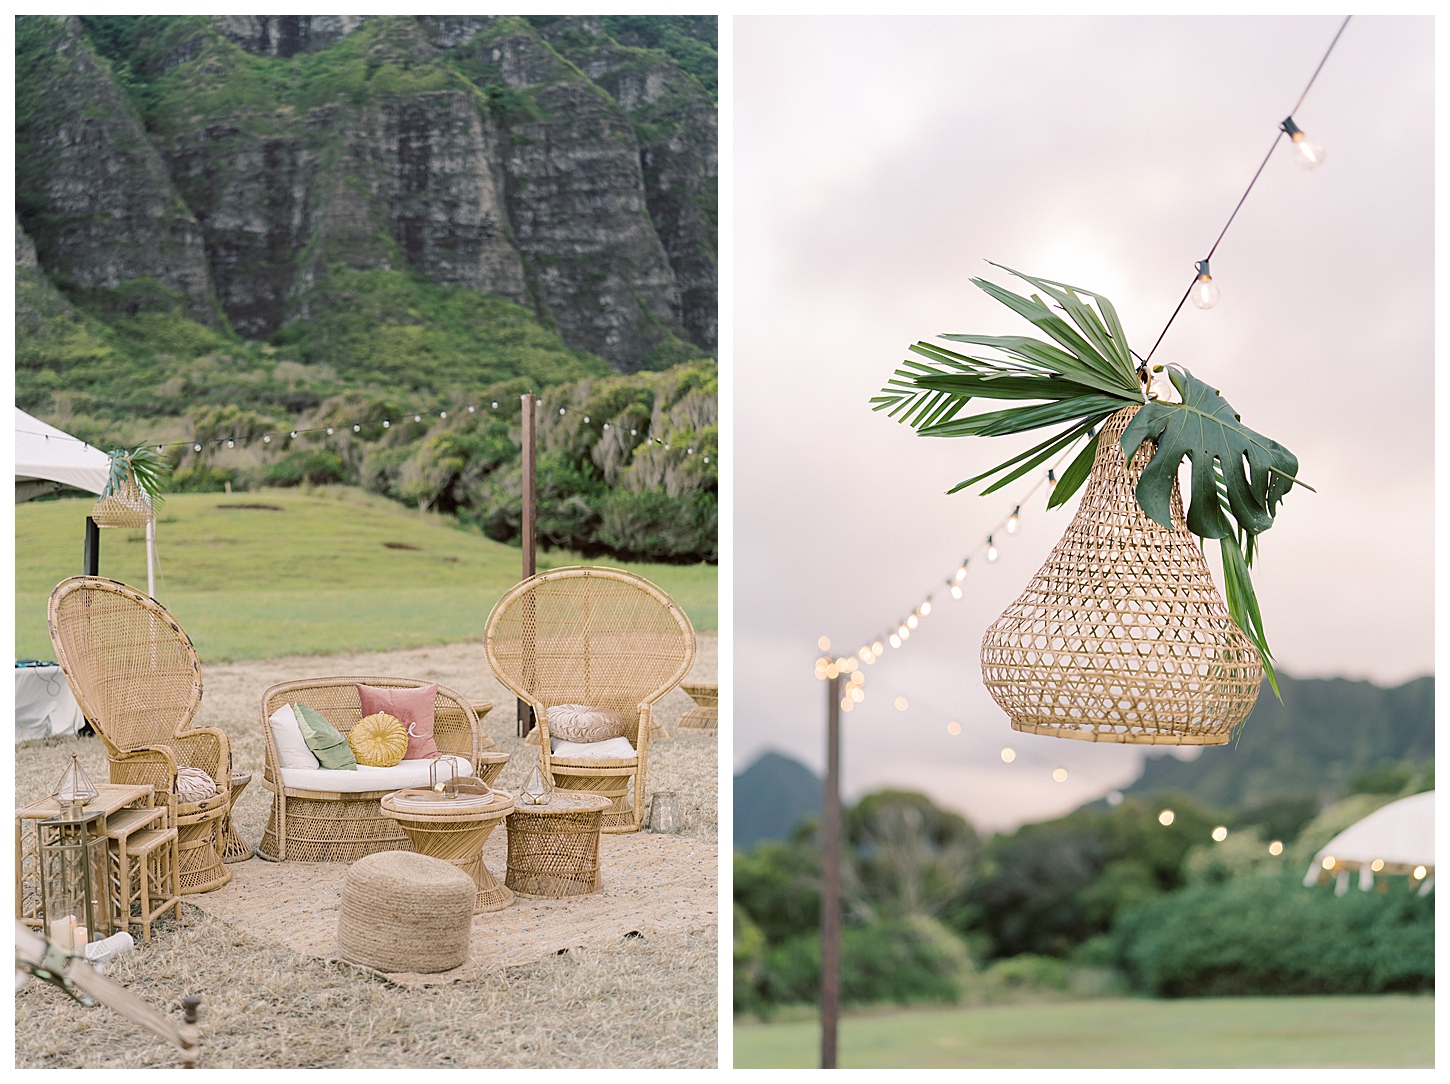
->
[734,16,1434,829]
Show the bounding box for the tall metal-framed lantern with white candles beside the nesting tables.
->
[36,806,112,952]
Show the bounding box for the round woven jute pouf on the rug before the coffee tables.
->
[338,851,479,974]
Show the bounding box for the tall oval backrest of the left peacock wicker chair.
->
[49,575,202,752]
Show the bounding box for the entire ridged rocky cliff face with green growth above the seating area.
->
[17,16,715,371]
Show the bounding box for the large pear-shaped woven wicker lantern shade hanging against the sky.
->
[982,406,1263,745]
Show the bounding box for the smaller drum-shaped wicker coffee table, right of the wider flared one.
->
[503,788,613,900]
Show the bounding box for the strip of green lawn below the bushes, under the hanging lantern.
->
[735,994,1436,1070]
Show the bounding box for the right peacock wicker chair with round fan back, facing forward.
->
[483,565,695,832]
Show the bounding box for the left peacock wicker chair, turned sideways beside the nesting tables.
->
[49,575,232,896]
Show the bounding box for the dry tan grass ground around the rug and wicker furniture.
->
[15,633,718,1068]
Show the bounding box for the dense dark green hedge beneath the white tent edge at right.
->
[1114,872,1436,997]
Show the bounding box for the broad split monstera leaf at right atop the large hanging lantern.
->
[1122,367,1309,538]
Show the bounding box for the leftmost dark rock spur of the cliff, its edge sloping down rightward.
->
[16,17,216,323]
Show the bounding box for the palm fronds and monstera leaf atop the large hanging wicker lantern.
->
[871,264,1304,693]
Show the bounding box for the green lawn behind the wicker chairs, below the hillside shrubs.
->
[15,487,716,662]
